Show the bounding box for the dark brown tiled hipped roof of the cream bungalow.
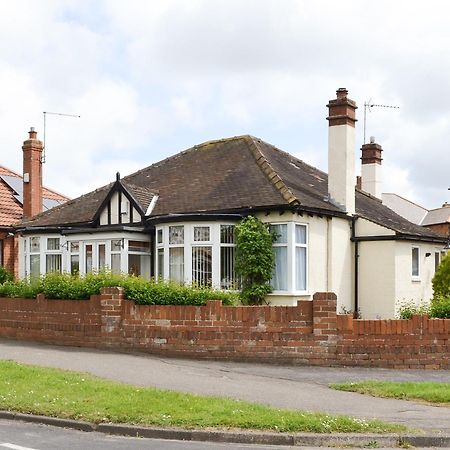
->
[18,135,446,243]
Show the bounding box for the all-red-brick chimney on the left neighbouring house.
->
[22,127,44,219]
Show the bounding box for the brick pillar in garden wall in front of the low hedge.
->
[100,287,124,347]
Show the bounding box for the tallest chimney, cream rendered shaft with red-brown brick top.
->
[327,88,357,214]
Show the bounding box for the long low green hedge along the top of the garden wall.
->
[0,272,238,305]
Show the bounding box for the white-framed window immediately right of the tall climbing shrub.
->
[270,222,308,293]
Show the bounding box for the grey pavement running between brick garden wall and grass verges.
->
[0,339,450,447]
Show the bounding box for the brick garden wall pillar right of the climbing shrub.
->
[313,292,337,341]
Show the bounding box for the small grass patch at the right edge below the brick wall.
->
[331,381,450,406]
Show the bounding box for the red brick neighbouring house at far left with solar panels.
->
[0,129,68,276]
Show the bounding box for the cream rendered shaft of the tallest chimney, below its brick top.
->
[328,125,355,214]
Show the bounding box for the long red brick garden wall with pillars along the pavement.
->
[0,288,450,369]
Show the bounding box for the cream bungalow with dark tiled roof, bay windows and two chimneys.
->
[17,89,446,318]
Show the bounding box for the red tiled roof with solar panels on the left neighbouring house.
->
[0,166,67,227]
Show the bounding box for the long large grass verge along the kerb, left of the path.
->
[0,361,406,433]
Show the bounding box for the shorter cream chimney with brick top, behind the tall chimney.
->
[361,136,383,199]
